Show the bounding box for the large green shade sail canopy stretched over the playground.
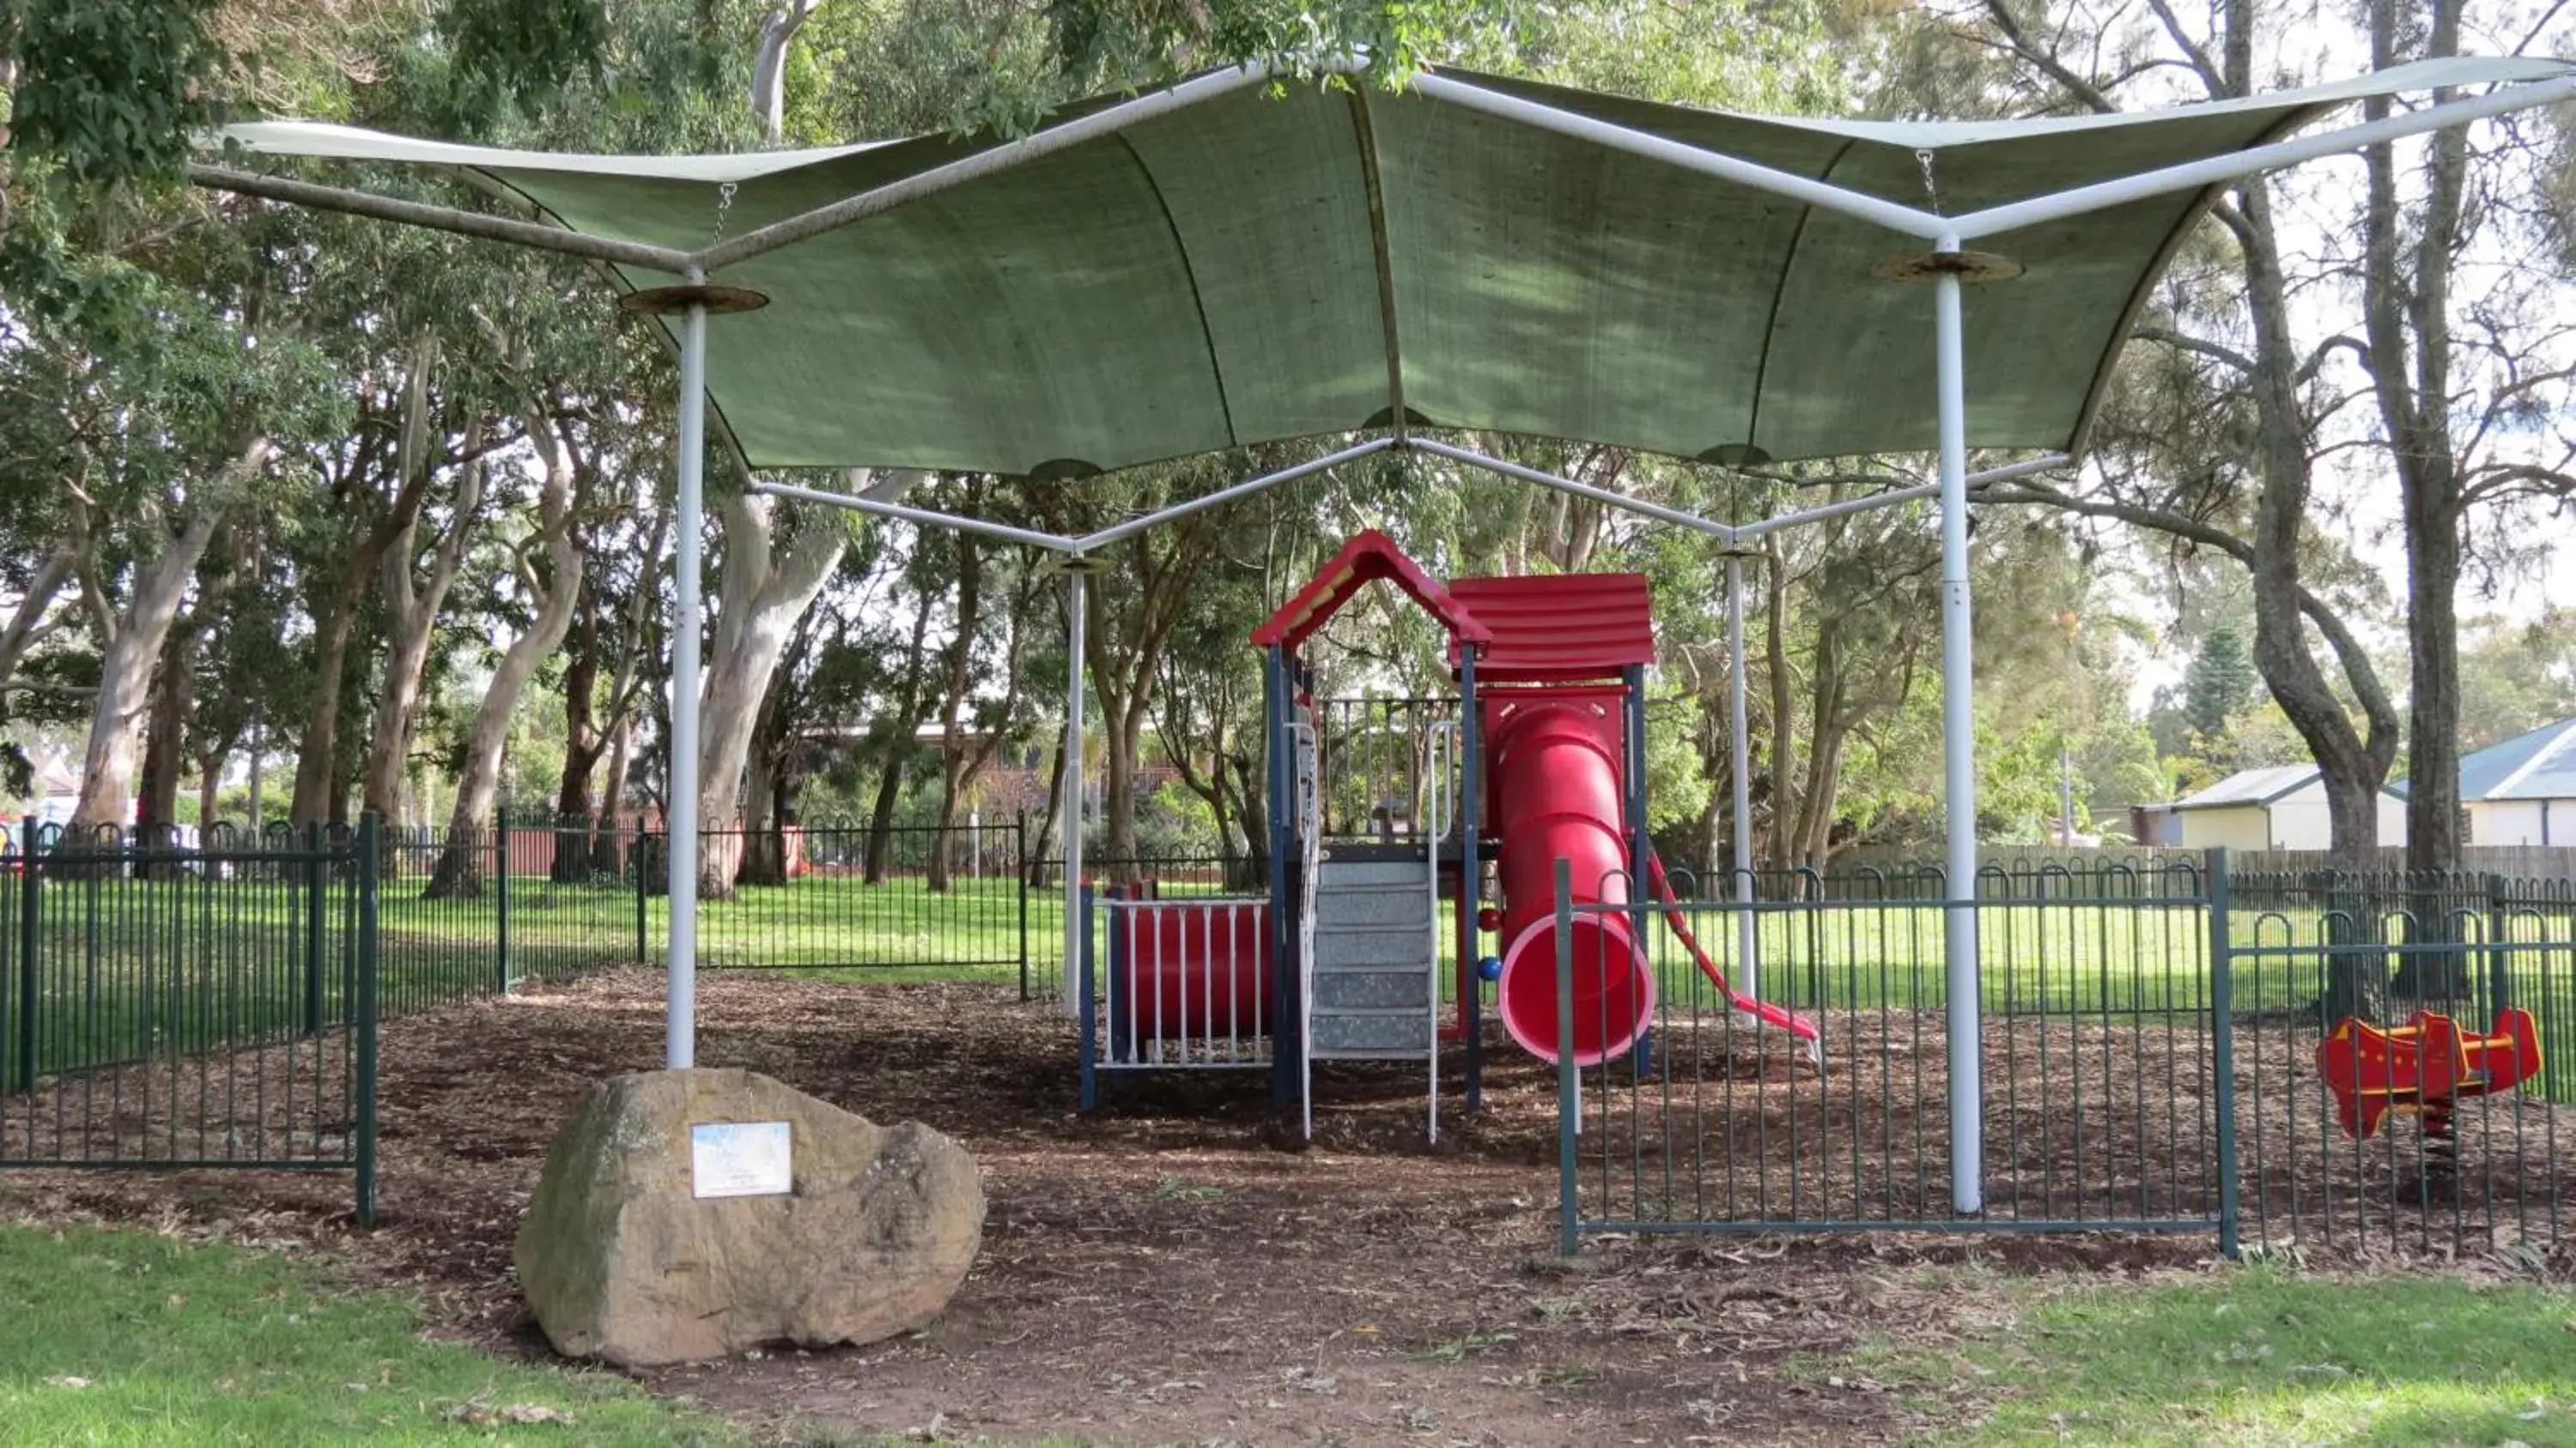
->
[227,59,2566,477]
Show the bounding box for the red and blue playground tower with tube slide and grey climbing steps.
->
[1079,531,1819,1136]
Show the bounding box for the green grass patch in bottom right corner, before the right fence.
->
[1855,1268,2576,1448]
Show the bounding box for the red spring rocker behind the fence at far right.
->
[2316,1007,2540,1141]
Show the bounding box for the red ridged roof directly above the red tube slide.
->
[1450,572,1654,683]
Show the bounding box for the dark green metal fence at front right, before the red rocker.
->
[1558,855,2576,1252]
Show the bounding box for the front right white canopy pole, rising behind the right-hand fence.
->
[1932,237,1986,1214]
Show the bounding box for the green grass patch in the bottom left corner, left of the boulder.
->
[0,1226,742,1448]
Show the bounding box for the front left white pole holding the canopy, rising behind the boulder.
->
[662,301,706,1072]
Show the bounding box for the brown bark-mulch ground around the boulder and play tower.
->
[0,971,2494,1445]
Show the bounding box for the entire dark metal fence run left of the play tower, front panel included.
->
[0,799,1239,1221]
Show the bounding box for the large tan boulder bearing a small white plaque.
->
[513,1069,984,1368]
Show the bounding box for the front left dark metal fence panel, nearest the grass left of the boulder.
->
[0,827,379,1221]
